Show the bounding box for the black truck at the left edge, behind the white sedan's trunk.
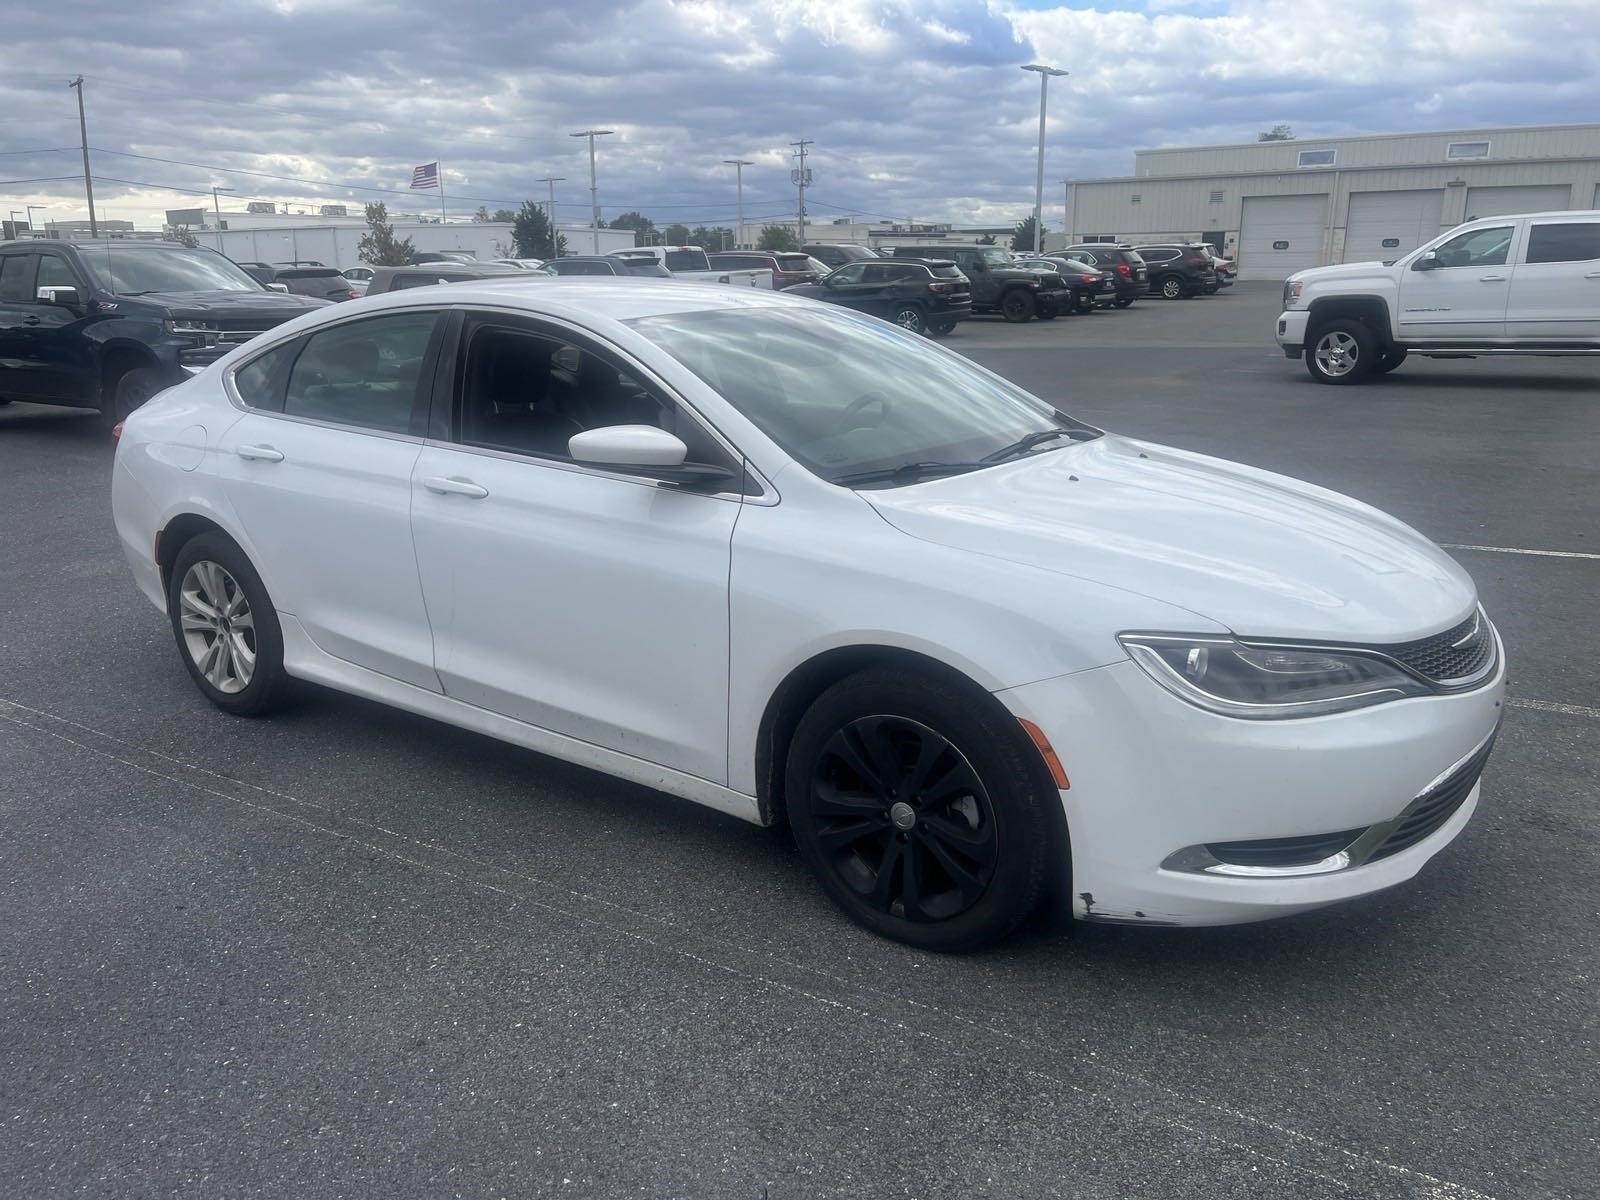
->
[0,240,328,421]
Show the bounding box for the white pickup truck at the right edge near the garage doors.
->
[1278,211,1600,384]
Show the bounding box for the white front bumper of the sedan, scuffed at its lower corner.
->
[998,658,1506,925]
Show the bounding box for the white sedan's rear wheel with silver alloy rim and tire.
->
[166,533,291,717]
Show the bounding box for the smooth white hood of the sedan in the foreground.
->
[861,435,1477,643]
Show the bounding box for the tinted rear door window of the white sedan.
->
[283,312,438,434]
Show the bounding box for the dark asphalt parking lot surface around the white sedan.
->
[0,285,1600,1200]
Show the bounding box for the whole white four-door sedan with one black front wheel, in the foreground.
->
[112,278,1506,950]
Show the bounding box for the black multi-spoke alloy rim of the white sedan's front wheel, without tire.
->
[806,714,1000,922]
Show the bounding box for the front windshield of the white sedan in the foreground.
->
[627,306,1093,485]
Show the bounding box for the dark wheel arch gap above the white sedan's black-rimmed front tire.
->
[755,642,1048,826]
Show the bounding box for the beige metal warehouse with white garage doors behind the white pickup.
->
[1066,125,1600,280]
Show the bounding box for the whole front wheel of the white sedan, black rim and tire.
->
[784,667,1067,952]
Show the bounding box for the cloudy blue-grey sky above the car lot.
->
[0,0,1600,226]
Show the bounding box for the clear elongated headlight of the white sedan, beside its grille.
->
[1117,634,1434,720]
